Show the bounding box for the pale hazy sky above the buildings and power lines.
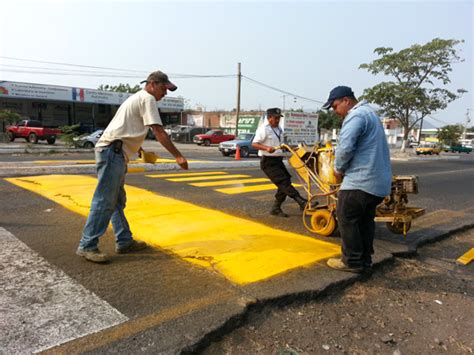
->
[0,0,474,127]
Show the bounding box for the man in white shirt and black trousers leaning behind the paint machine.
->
[252,108,307,217]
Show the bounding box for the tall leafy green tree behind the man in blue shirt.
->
[359,38,466,151]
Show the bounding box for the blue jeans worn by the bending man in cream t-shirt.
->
[79,146,133,250]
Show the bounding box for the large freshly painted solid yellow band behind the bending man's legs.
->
[5,175,340,284]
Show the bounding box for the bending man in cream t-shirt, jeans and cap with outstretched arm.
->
[76,71,188,263]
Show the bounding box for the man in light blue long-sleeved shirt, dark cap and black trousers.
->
[323,86,392,272]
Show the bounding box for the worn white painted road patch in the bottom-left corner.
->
[0,227,128,354]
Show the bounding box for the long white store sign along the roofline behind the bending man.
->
[0,81,184,111]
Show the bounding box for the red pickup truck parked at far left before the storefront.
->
[6,120,61,144]
